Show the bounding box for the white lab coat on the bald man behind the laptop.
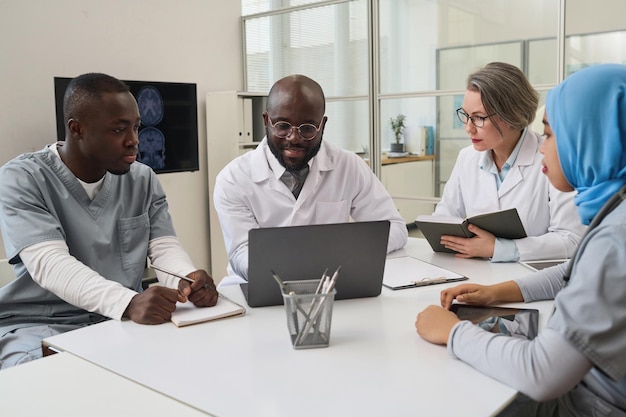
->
[213,138,408,278]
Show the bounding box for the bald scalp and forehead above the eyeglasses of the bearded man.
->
[267,74,326,116]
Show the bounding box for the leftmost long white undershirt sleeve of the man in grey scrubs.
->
[20,240,137,320]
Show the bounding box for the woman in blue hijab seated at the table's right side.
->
[415,64,626,417]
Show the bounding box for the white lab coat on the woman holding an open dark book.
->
[434,129,585,261]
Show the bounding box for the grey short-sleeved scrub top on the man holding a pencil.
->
[0,145,175,328]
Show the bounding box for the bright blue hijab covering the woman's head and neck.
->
[546,64,626,224]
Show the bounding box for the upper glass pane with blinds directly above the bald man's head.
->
[243,0,369,97]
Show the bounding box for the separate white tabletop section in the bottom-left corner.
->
[0,352,213,417]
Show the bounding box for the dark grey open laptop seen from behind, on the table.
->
[241,220,390,307]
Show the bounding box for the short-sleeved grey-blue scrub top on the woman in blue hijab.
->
[546,202,626,409]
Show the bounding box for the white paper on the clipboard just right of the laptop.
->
[383,256,467,290]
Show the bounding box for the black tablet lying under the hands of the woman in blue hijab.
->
[450,303,539,340]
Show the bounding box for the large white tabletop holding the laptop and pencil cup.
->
[45,238,552,417]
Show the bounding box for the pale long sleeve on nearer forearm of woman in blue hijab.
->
[448,321,592,401]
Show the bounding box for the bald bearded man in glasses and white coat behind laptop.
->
[213,75,408,285]
